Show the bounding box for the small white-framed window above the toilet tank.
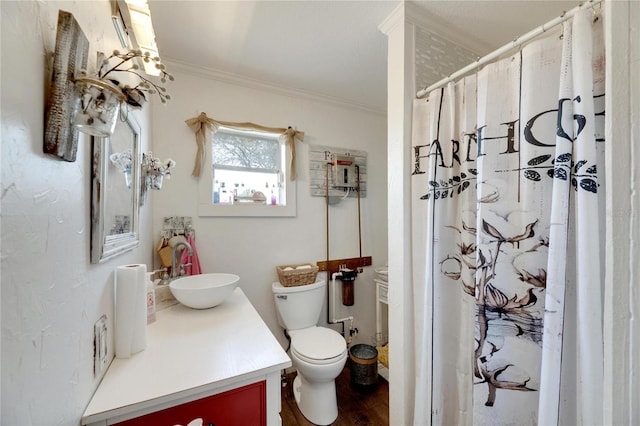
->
[200,127,295,216]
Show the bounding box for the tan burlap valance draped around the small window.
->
[185,112,304,181]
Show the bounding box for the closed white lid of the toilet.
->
[291,327,347,360]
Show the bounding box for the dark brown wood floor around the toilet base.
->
[280,362,389,426]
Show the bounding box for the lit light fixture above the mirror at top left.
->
[111,0,160,76]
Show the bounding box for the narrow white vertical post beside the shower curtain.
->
[380,2,418,425]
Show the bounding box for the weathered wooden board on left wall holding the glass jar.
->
[44,10,89,162]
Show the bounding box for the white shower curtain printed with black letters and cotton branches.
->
[411,10,605,425]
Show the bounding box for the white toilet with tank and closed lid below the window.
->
[271,280,348,425]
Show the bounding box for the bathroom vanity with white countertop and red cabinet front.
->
[82,288,291,426]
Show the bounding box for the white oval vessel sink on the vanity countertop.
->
[169,273,240,309]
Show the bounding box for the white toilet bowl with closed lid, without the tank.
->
[290,327,348,425]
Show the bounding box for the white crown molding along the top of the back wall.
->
[162,57,387,116]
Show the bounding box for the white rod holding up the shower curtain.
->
[416,0,602,99]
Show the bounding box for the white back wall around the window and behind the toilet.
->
[149,62,387,350]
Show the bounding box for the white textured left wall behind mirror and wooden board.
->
[0,1,151,425]
